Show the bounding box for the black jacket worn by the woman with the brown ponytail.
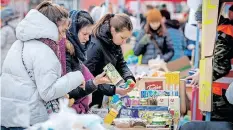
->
[84,23,135,107]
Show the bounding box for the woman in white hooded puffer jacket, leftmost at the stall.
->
[1,2,84,130]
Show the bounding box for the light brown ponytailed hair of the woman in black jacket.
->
[93,14,133,37]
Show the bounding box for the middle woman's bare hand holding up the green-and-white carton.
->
[93,72,111,86]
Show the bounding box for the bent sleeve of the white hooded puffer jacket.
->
[33,46,84,101]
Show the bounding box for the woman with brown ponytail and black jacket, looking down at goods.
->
[84,14,136,108]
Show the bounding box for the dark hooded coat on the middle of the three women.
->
[66,11,97,100]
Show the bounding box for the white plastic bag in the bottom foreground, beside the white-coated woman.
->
[28,99,105,130]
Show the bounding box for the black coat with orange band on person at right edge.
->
[211,17,233,123]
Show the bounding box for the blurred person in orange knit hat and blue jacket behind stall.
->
[133,9,174,64]
